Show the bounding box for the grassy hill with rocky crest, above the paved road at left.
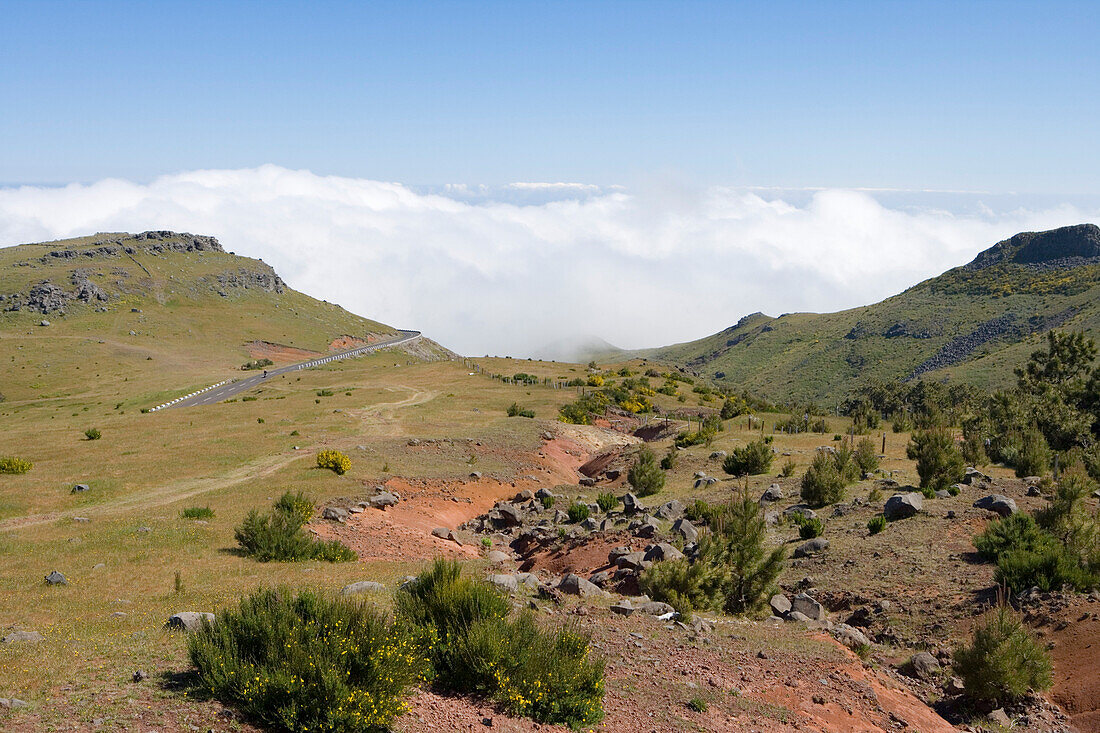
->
[0,231,395,405]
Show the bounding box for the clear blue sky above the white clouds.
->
[0,0,1100,191]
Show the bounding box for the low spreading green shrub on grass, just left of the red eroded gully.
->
[233,491,356,562]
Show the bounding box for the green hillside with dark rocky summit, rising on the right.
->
[636,225,1100,403]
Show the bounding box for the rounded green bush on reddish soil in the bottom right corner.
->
[954,605,1052,707]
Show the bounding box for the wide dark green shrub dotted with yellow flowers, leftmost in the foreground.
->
[187,589,428,733]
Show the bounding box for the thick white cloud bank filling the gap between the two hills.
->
[0,166,1100,355]
